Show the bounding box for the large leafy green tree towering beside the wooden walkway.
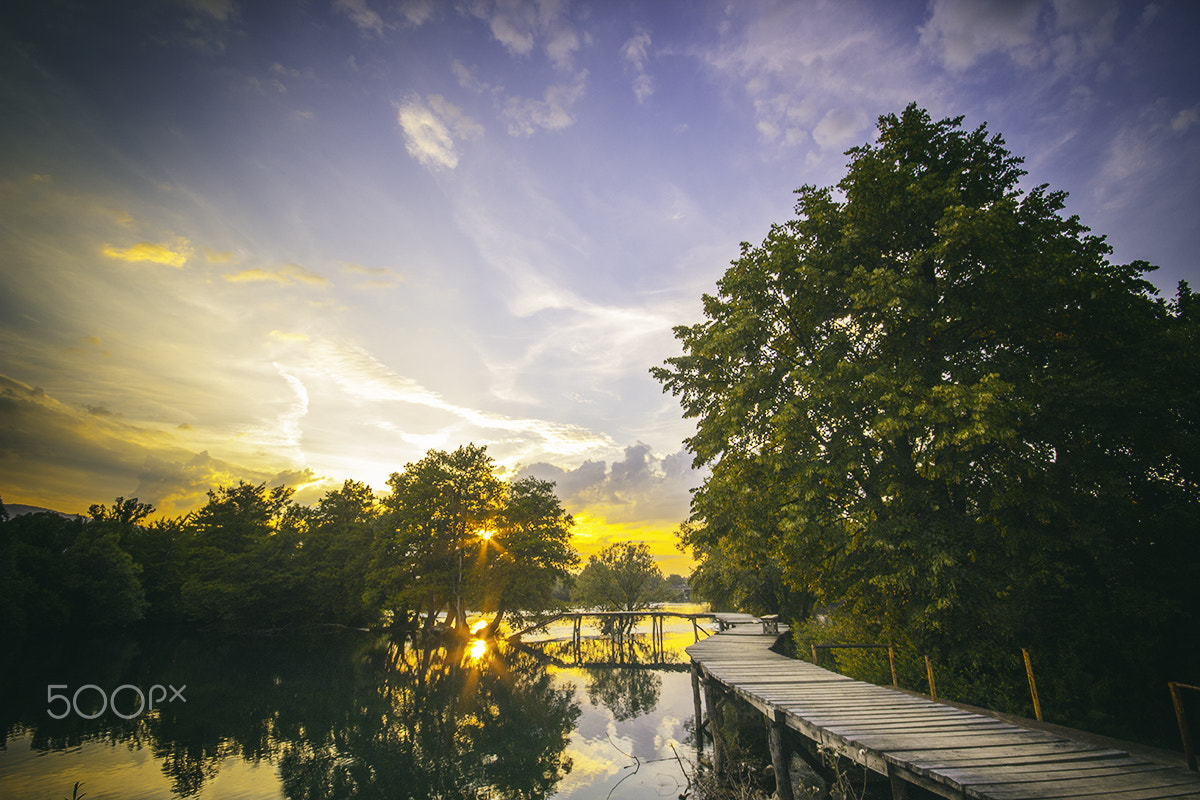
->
[654,106,1200,738]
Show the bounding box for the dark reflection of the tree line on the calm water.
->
[0,636,580,800]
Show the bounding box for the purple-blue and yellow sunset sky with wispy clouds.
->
[0,0,1200,572]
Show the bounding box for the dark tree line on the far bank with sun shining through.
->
[0,445,578,634]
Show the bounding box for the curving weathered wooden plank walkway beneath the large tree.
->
[686,624,1200,800]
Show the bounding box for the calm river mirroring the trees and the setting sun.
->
[0,606,702,800]
